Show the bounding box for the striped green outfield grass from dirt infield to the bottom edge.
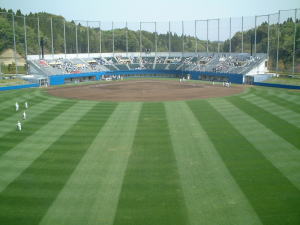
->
[0,87,300,225]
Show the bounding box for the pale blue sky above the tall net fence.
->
[0,0,300,21]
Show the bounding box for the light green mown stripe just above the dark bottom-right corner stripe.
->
[210,99,300,190]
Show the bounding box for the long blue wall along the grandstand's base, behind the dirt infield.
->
[49,70,244,85]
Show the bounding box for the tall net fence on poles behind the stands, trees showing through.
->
[0,9,300,75]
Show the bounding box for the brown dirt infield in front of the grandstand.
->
[48,80,245,101]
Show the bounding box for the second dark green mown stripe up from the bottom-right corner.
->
[227,96,300,149]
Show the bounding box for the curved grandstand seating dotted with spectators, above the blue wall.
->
[28,53,267,76]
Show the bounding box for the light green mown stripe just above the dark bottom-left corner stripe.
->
[0,103,95,192]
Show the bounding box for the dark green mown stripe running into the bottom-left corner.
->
[0,103,116,225]
